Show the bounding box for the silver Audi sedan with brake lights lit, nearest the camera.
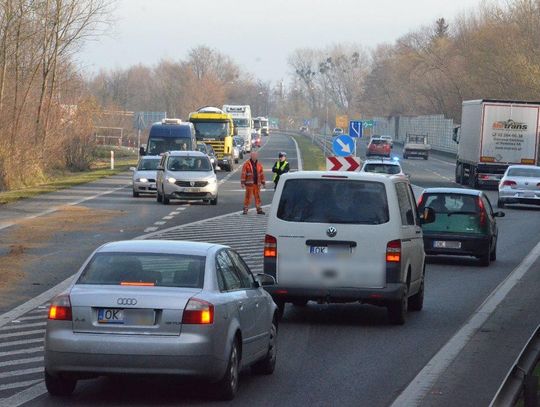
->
[45,240,277,400]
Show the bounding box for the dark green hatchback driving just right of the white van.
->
[418,188,505,267]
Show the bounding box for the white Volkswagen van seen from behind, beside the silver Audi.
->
[264,171,434,324]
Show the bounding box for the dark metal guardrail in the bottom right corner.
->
[490,326,540,407]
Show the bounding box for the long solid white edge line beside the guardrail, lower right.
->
[391,242,540,407]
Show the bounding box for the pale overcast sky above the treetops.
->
[80,0,479,81]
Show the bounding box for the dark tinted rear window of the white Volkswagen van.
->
[277,179,389,225]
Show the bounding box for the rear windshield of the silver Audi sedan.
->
[77,253,206,288]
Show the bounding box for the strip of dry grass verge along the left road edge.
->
[0,157,137,204]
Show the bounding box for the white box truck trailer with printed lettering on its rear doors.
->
[453,99,540,188]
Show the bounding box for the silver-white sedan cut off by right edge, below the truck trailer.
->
[497,165,540,208]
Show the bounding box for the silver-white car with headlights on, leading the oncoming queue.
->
[156,151,218,205]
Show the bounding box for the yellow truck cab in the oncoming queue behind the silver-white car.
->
[189,106,234,171]
